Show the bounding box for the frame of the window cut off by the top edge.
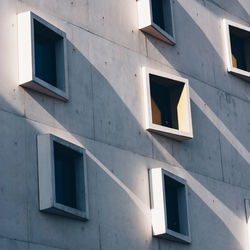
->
[137,0,176,45]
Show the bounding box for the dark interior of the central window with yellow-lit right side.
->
[149,74,184,129]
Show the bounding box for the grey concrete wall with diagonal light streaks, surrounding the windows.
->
[0,0,250,250]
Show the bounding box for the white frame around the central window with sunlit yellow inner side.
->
[142,67,193,141]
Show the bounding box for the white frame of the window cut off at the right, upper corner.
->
[223,19,250,82]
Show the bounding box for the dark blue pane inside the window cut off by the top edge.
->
[151,0,173,36]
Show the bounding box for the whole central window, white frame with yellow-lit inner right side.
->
[143,68,193,140]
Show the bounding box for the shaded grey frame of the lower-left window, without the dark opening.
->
[37,134,89,221]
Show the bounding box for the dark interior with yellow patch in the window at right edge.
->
[229,26,250,71]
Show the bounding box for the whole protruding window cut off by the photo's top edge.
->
[137,0,175,45]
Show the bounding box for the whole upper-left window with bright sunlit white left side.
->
[18,12,68,101]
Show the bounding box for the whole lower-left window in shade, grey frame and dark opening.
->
[37,134,88,220]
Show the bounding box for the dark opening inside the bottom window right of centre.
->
[164,175,185,233]
